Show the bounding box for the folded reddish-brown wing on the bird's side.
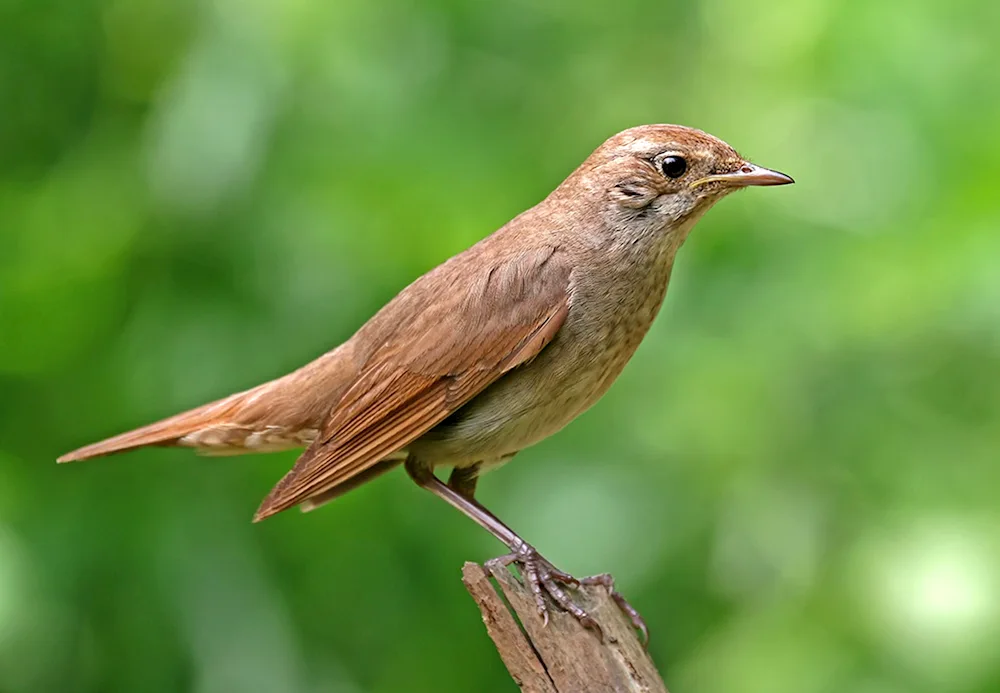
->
[254,247,570,521]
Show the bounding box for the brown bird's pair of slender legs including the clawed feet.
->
[405,457,649,645]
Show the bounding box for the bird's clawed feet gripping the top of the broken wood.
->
[486,544,649,646]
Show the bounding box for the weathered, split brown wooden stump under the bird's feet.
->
[462,563,668,693]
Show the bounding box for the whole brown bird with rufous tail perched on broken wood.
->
[58,124,794,642]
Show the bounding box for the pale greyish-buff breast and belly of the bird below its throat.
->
[411,235,673,465]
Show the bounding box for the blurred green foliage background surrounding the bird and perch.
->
[0,0,1000,693]
